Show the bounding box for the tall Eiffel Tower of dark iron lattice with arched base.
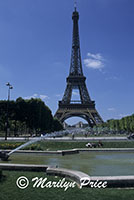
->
[54,6,103,127]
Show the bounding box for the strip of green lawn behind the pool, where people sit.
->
[0,141,134,151]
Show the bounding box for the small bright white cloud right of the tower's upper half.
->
[84,53,104,70]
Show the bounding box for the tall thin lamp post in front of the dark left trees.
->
[5,82,13,140]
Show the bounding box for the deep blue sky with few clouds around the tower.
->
[0,0,134,122]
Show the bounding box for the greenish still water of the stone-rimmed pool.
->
[1,152,134,176]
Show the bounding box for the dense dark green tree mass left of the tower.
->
[0,97,63,136]
